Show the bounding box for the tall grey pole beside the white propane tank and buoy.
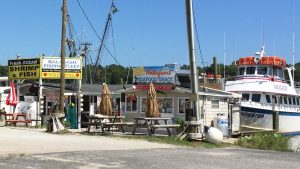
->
[185,0,201,129]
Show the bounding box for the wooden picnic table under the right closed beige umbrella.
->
[132,117,180,136]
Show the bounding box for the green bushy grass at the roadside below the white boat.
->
[236,133,292,151]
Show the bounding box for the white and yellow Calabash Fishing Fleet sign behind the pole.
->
[41,57,82,79]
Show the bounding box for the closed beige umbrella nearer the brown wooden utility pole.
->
[100,83,112,116]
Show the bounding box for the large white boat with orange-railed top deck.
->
[225,47,300,135]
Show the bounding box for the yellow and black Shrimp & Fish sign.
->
[8,58,40,80]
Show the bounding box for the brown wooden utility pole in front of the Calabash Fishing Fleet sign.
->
[59,0,67,113]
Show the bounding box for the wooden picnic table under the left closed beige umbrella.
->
[87,115,133,133]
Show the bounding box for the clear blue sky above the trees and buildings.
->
[0,0,300,67]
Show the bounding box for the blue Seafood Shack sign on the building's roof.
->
[133,66,176,84]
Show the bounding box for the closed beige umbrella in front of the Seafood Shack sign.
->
[146,83,160,117]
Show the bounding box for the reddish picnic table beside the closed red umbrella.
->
[5,113,31,127]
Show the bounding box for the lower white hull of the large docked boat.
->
[241,106,300,135]
